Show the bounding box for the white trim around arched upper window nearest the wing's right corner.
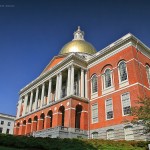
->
[118,60,129,88]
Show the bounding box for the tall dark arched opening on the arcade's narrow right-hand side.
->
[75,105,82,129]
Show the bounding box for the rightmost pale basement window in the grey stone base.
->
[124,126,134,141]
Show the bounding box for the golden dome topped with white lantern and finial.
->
[60,27,96,54]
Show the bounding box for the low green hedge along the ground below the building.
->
[0,134,148,150]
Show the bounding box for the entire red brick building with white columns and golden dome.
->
[14,28,150,140]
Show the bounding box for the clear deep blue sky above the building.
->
[0,0,150,115]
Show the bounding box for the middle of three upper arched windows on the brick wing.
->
[105,69,112,88]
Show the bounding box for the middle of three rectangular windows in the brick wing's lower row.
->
[106,98,113,119]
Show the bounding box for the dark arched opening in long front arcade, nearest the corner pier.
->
[58,106,65,126]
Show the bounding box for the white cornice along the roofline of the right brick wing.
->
[87,33,150,68]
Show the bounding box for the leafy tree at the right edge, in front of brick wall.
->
[131,97,150,133]
